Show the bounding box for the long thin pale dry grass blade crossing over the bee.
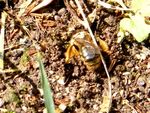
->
[75,0,112,113]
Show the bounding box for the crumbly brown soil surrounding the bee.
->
[0,0,150,113]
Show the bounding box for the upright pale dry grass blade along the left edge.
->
[0,11,7,70]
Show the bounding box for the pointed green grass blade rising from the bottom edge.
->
[37,53,55,113]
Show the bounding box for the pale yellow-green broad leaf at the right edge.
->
[120,15,150,42]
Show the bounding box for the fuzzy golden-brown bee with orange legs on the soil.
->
[65,31,109,70]
